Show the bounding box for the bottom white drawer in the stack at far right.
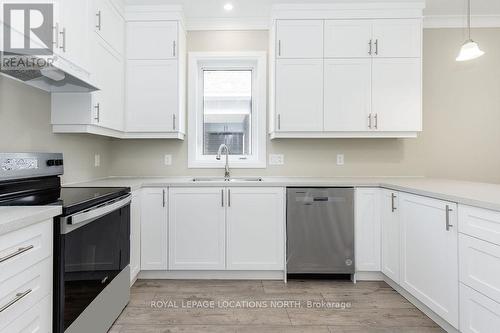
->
[460,284,500,333]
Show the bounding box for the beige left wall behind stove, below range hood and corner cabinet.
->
[0,76,110,182]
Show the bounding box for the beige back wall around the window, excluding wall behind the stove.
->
[110,29,500,182]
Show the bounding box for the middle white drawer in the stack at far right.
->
[458,234,500,302]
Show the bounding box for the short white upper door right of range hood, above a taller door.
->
[94,0,125,55]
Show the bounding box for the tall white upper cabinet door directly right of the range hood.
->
[93,38,124,130]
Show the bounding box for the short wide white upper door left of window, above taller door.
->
[127,21,178,60]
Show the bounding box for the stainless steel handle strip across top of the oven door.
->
[61,194,131,234]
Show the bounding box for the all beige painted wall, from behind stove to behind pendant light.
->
[0,29,500,183]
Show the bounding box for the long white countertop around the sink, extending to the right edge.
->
[69,176,500,211]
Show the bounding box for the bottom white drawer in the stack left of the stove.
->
[0,296,52,333]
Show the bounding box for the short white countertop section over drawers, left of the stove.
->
[0,206,62,235]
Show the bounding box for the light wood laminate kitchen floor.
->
[110,280,444,333]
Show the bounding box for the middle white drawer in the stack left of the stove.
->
[0,257,52,330]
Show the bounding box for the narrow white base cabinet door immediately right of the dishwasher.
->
[354,188,380,272]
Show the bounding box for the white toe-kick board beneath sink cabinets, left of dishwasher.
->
[139,271,284,281]
